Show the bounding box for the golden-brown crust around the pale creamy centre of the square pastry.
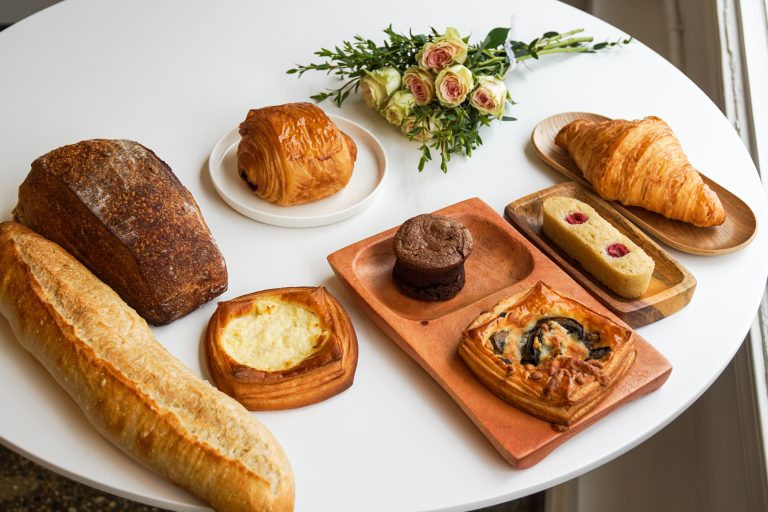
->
[205,286,357,410]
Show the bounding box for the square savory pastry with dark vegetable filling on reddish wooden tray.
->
[459,282,635,426]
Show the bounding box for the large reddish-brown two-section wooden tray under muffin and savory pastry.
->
[328,198,672,468]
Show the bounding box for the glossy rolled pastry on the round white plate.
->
[237,103,357,206]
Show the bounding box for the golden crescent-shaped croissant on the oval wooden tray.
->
[555,116,725,226]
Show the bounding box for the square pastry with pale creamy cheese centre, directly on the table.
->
[205,287,357,410]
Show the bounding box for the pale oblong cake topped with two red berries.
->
[542,196,655,299]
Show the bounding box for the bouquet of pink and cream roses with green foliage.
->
[288,26,631,172]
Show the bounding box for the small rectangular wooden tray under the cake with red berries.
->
[504,181,696,327]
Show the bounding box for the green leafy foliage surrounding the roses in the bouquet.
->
[286,25,632,172]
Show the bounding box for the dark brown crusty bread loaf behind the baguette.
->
[13,139,227,325]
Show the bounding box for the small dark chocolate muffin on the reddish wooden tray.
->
[392,214,472,301]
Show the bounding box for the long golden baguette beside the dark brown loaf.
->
[0,222,294,511]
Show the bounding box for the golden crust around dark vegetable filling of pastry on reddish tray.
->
[458,281,636,426]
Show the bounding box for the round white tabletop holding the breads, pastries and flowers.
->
[0,0,768,511]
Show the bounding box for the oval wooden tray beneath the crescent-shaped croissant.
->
[531,112,757,256]
